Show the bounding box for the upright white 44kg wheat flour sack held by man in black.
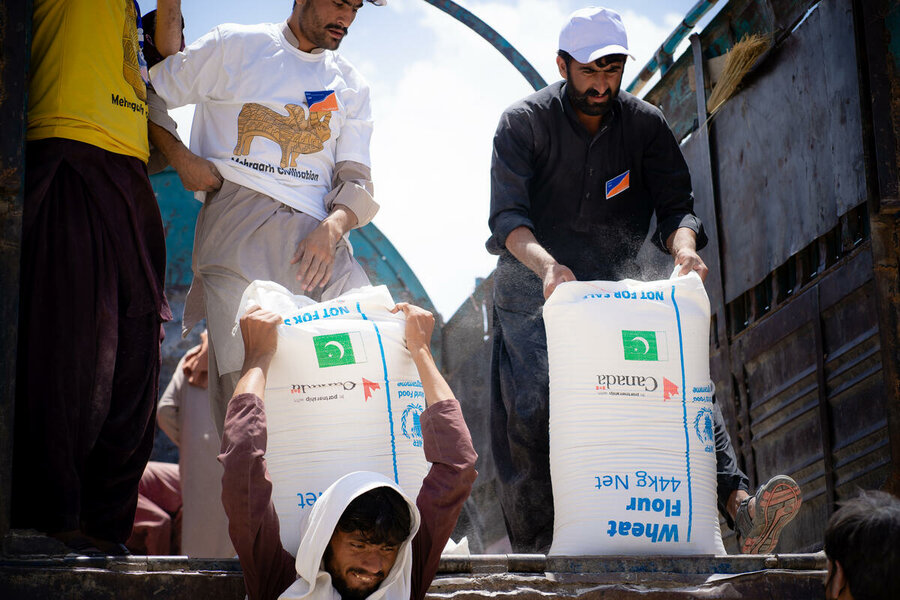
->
[544,273,725,556]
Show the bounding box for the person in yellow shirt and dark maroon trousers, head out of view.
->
[12,0,180,554]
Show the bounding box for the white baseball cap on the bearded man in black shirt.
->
[559,6,634,64]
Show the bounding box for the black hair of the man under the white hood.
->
[337,487,412,545]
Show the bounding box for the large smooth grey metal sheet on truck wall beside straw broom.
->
[713,0,866,302]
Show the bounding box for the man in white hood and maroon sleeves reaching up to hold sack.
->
[219,302,477,600]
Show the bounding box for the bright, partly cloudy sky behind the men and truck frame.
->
[140,0,726,321]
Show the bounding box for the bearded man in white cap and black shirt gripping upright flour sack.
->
[486,7,800,552]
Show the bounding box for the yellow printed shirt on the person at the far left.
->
[27,0,149,162]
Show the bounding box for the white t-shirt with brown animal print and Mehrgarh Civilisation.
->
[150,23,372,219]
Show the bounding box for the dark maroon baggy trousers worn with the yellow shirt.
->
[12,139,171,542]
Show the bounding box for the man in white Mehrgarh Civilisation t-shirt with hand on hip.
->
[150,0,387,433]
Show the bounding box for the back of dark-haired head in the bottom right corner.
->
[825,491,900,600]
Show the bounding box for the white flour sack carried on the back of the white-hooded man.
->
[241,281,429,554]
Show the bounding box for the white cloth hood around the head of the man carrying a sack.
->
[279,471,420,600]
